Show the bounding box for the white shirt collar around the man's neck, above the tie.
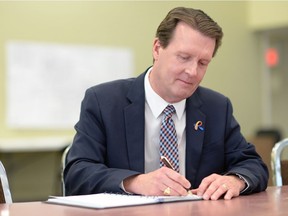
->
[144,67,186,119]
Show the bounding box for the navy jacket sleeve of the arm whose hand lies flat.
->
[225,100,269,194]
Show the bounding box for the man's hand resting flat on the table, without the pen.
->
[191,174,245,200]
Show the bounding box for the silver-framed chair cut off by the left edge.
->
[0,161,12,204]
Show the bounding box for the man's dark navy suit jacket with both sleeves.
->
[64,69,268,195]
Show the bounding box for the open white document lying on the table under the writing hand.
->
[46,193,202,209]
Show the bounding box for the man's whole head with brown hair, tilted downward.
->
[149,7,223,103]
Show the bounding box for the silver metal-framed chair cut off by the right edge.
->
[271,138,288,186]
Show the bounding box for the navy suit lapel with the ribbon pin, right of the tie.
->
[186,92,206,186]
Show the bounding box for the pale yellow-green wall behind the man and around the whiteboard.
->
[0,1,288,138]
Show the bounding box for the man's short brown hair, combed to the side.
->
[156,7,223,57]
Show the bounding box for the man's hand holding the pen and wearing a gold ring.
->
[123,167,191,196]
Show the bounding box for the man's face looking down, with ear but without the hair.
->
[149,22,215,103]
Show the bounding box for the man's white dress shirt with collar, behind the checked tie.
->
[144,68,186,176]
